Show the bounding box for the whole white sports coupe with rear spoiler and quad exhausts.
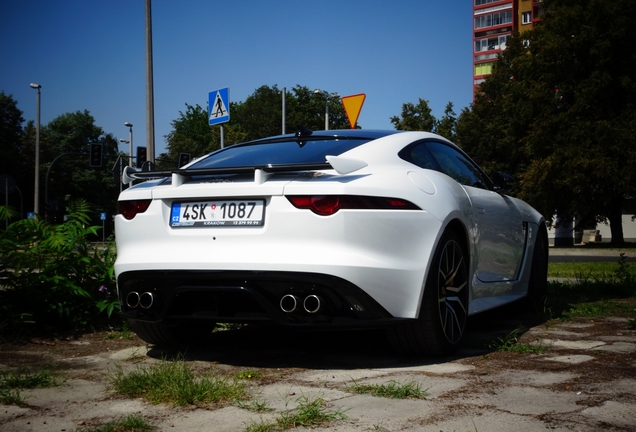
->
[115,129,548,355]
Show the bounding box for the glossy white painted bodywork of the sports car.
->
[115,131,543,330]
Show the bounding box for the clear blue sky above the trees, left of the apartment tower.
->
[0,0,472,155]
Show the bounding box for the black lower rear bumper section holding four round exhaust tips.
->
[117,270,393,327]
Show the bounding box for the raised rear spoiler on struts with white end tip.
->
[122,156,367,186]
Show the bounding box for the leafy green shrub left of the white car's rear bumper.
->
[0,201,119,331]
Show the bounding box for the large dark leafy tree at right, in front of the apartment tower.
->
[458,0,636,244]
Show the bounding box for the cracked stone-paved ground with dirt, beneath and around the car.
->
[0,311,636,432]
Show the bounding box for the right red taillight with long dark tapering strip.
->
[287,195,420,216]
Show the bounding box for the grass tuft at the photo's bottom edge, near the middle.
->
[244,396,347,432]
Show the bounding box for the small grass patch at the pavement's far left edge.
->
[0,366,59,405]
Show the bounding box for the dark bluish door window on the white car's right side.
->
[427,141,491,189]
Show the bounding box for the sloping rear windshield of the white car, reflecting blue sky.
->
[189,137,372,169]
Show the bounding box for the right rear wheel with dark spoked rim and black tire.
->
[389,231,469,356]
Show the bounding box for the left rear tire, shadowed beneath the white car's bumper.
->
[128,320,216,346]
